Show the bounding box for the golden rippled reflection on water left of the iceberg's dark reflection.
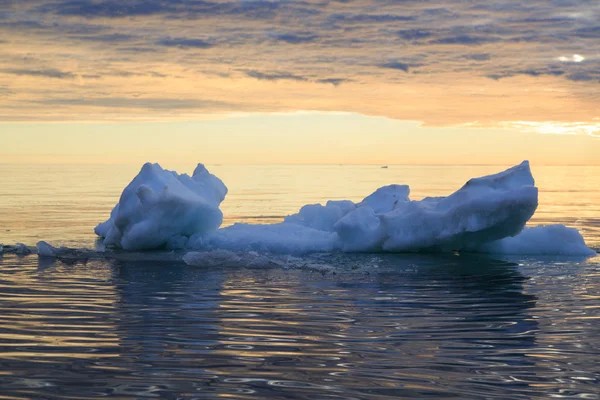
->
[0,256,119,361]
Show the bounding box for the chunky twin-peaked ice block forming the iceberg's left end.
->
[95,163,227,250]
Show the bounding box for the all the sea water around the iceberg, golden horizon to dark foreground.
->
[0,165,600,399]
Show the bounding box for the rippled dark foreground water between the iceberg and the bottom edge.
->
[0,254,600,399]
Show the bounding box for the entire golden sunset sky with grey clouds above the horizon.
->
[0,0,600,165]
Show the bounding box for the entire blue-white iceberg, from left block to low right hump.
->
[96,161,595,255]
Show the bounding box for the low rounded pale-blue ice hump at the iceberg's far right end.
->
[477,225,596,256]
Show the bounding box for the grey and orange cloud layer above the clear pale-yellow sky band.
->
[0,0,600,123]
